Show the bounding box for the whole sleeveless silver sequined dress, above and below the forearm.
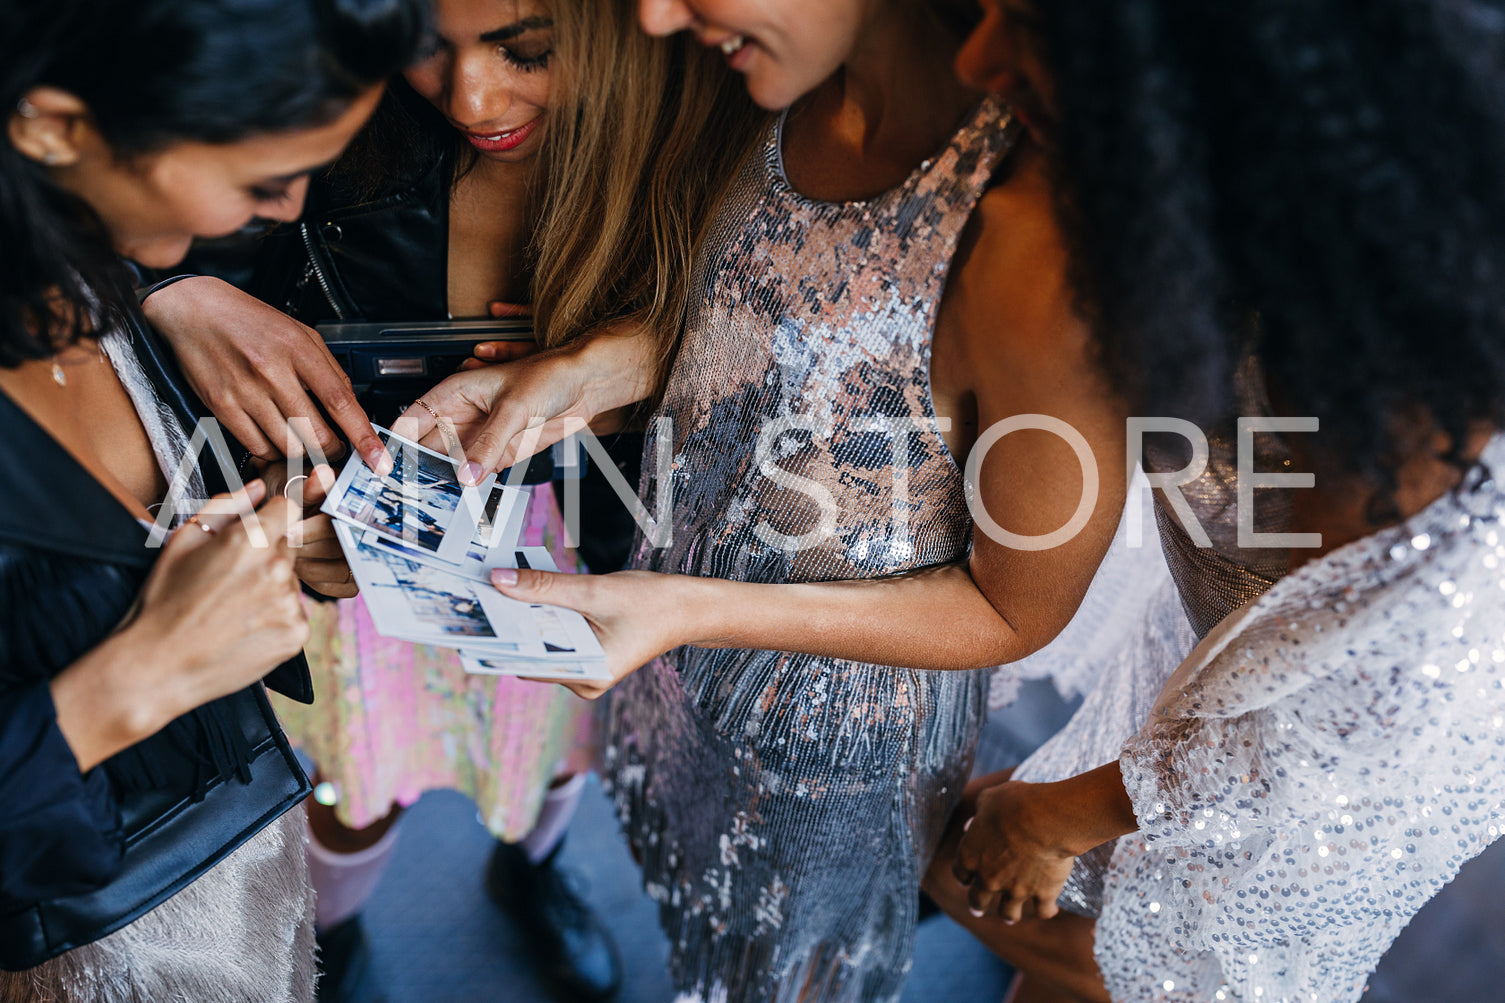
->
[607,101,1013,1001]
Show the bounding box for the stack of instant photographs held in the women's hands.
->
[322,426,611,682]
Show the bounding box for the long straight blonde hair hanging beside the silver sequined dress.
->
[530,0,766,384]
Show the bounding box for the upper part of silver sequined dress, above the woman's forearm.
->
[640,117,1005,581]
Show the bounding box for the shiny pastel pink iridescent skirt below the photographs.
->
[272,483,596,840]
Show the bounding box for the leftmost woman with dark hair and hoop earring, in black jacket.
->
[0,0,423,1003]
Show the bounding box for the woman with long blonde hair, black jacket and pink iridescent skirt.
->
[146,0,757,998]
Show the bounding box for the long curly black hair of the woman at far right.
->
[1035,0,1505,483]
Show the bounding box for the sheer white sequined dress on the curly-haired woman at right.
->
[1097,435,1505,1003]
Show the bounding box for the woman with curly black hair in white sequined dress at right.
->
[929,0,1505,1003]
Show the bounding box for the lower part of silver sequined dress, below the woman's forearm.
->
[607,649,987,1003]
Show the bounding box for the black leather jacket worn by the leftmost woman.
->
[0,313,312,971]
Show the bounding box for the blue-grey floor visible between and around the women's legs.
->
[346,687,1505,1003]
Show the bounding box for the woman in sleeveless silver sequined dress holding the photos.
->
[412,2,1124,1000]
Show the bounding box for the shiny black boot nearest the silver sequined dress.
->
[486,843,622,1003]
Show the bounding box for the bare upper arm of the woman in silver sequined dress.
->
[932,160,1127,664]
